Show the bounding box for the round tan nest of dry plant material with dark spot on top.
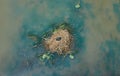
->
[44,29,73,54]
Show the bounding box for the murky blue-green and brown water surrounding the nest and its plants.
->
[0,0,120,76]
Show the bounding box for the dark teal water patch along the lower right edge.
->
[102,40,120,76]
